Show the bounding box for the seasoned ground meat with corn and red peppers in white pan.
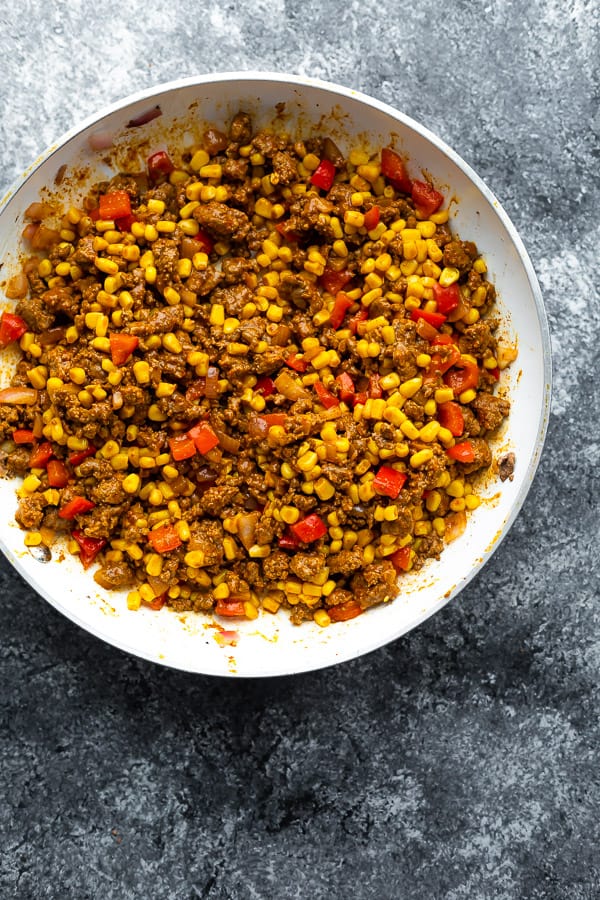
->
[0,111,512,626]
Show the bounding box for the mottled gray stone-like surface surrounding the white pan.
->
[0,0,600,900]
